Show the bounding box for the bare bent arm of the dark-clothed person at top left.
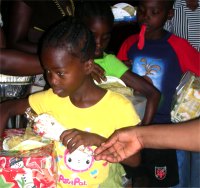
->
[7,0,37,53]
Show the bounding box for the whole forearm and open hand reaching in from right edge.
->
[95,118,200,162]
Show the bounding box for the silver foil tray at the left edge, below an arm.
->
[0,74,34,97]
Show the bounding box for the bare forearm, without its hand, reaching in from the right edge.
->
[140,119,200,151]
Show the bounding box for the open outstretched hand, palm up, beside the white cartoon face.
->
[95,127,142,163]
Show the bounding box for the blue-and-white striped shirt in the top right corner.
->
[164,0,200,51]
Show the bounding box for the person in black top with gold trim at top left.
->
[2,0,75,92]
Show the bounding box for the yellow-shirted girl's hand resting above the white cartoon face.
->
[60,129,105,153]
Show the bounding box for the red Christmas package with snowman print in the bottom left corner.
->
[0,129,57,188]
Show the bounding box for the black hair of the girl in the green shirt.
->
[75,0,114,26]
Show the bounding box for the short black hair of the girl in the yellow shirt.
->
[40,16,96,61]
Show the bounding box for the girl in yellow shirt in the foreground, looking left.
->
[0,17,140,188]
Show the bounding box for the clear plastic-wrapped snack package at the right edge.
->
[171,72,200,122]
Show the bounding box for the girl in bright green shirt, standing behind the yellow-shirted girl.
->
[75,1,160,125]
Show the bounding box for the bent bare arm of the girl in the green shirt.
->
[121,70,160,125]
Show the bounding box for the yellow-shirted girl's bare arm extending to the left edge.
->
[0,98,29,138]
